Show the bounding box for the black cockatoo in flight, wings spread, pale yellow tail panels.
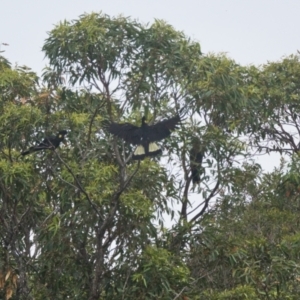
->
[106,115,180,160]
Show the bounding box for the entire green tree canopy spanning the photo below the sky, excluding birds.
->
[0,13,300,300]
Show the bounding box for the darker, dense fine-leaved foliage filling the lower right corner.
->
[189,159,300,299]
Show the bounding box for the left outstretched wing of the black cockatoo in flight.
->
[105,122,142,145]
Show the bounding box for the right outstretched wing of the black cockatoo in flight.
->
[147,115,180,142]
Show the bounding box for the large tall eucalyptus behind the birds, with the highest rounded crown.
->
[0,13,257,299]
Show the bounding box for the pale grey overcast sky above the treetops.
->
[0,0,300,170]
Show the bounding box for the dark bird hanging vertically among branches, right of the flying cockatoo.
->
[190,138,204,184]
